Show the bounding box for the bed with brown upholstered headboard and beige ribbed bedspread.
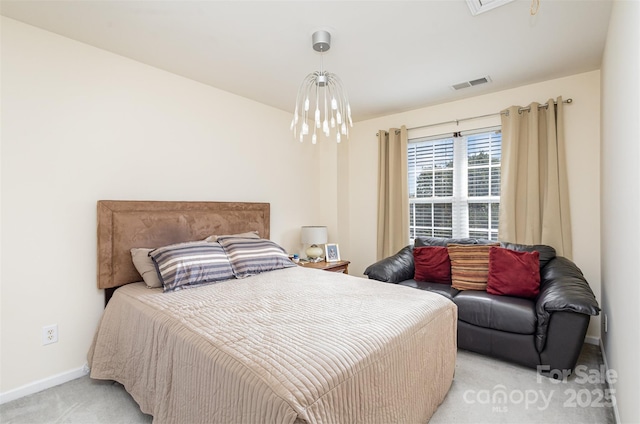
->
[88,201,457,423]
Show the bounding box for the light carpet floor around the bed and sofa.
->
[0,344,615,424]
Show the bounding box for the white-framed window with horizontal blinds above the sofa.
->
[407,128,502,241]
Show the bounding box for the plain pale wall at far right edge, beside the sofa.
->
[601,1,640,423]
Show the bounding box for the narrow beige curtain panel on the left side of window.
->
[377,126,409,259]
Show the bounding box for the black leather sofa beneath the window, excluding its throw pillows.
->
[364,237,600,378]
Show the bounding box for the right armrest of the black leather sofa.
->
[536,256,600,352]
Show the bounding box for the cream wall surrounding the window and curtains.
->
[340,71,600,338]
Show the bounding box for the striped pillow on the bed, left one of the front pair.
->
[149,241,233,292]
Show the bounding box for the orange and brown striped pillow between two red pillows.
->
[447,243,499,290]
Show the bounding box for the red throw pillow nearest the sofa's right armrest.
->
[487,247,540,298]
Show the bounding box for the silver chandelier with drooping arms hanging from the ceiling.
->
[291,31,353,144]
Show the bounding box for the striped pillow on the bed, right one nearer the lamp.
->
[219,238,297,278]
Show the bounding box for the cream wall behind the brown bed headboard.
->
[0,17,337,398]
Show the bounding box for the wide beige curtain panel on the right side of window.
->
[498,97,572,258]
